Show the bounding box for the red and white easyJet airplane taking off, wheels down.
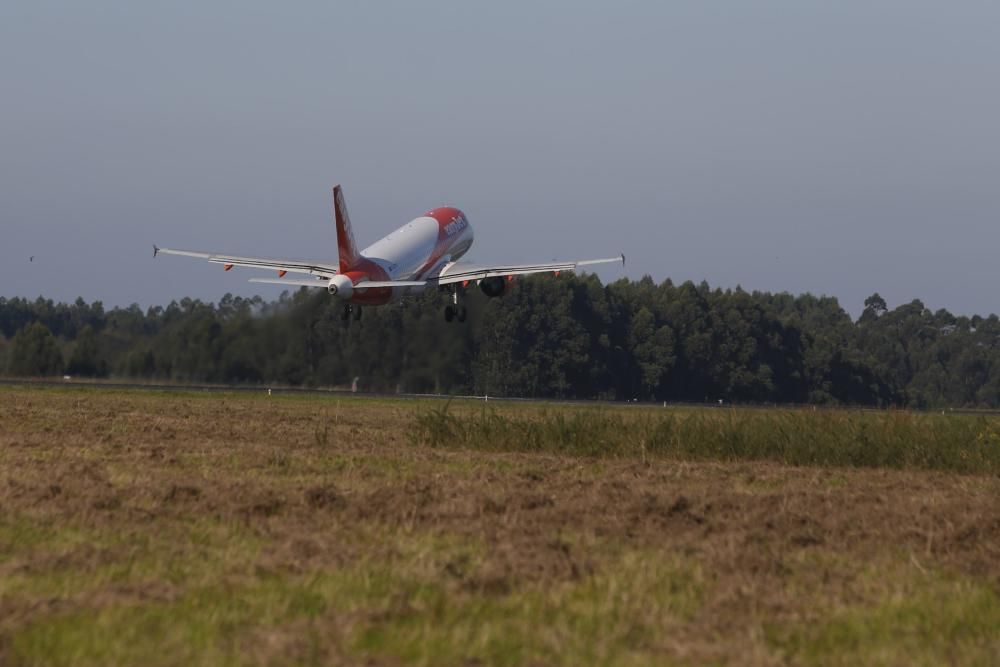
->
[153,185,625,322]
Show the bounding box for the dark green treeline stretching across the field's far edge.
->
[0,276,1000,408]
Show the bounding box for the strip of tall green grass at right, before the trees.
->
[413,405,1000,474]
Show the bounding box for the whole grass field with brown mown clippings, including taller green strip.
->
[0,388,1000,665]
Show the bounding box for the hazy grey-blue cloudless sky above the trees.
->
[0,0,1000,314]
